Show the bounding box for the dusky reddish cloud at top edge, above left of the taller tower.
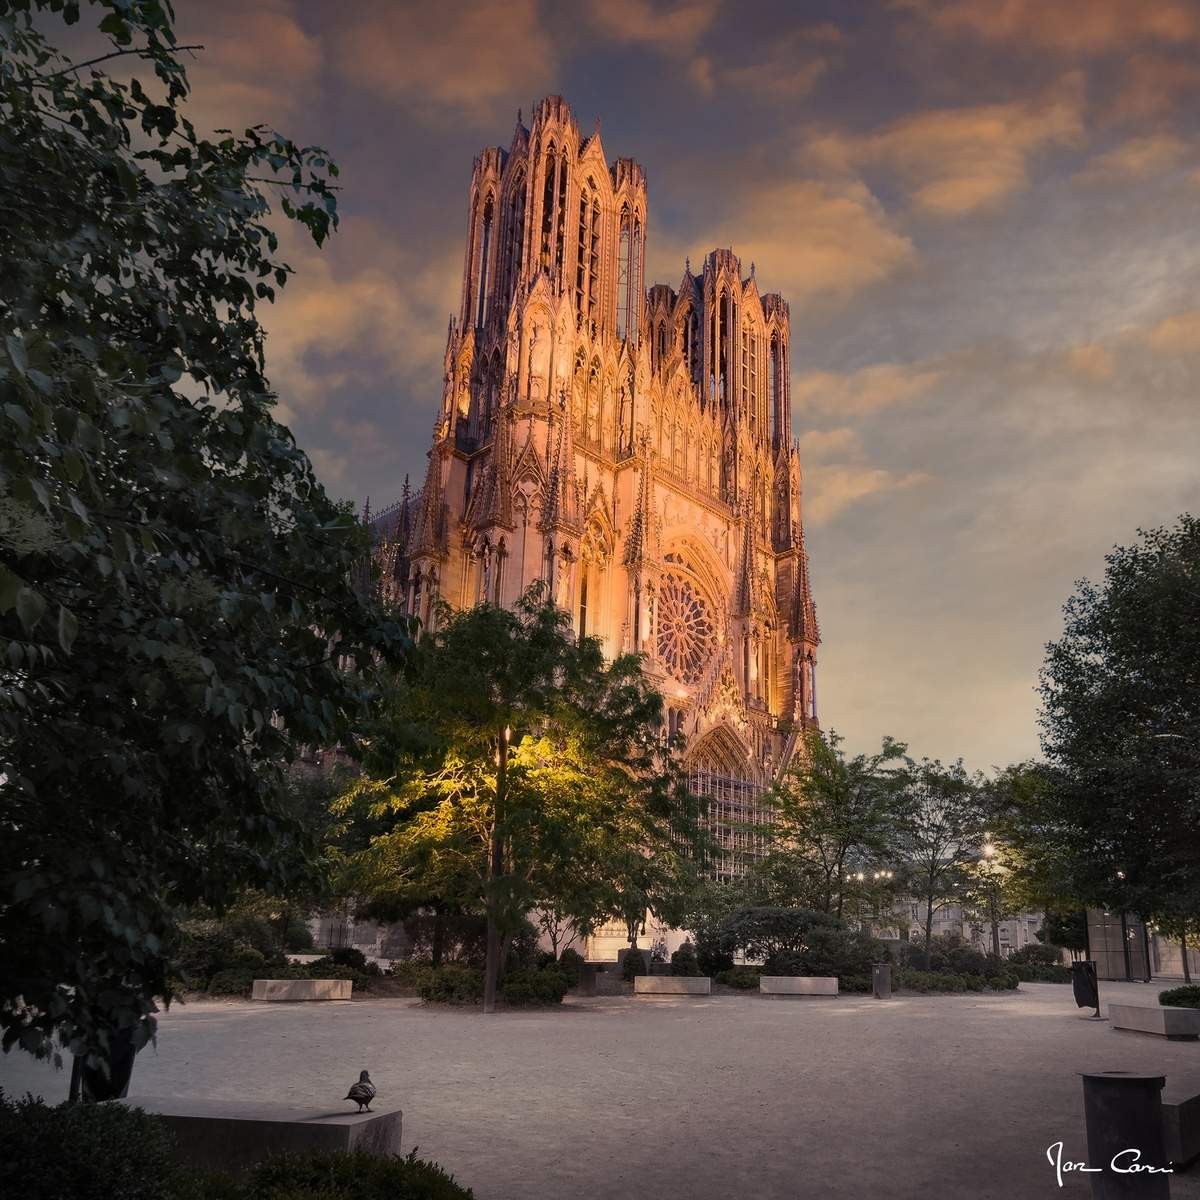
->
[331,0,558,124]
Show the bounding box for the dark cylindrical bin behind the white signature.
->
[1084,1070,1171,1200]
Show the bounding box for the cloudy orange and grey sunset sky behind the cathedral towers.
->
[93,0,1200,769]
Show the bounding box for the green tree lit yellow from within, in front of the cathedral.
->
[343,586,697,1012]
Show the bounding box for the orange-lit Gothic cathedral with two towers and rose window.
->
[372,96,820,892]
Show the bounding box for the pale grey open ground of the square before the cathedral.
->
[0,984,1200,1200]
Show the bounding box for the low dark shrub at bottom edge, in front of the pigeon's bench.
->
[245,1147,474,1200]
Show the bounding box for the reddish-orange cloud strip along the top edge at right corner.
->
[894,0,1200,55]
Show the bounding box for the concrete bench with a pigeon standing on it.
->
[120,1087,403,1174]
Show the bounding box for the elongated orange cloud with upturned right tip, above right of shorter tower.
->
[803,76,1084,217]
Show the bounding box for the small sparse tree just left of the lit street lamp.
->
[901,758,989,950]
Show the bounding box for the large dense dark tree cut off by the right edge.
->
[1028,515,1200,919]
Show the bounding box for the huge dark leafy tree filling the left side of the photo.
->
[0,0,408,1069]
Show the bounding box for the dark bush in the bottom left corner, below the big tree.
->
[0,1091,181,1200]
